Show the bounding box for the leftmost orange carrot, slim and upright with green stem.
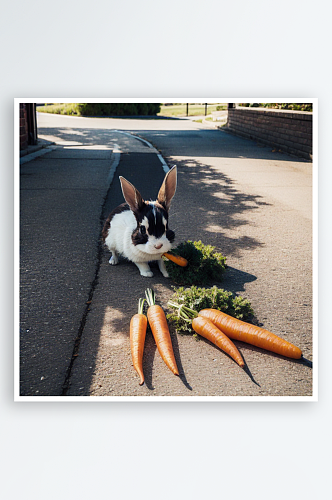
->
[130,299,148,385]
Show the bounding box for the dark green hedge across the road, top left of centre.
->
[77,102,160,116]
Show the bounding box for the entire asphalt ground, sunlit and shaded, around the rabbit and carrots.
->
[20,115,313,400]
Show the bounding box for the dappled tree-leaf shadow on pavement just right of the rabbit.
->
[170,156,267,257]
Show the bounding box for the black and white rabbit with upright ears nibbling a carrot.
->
[102,166,177,278]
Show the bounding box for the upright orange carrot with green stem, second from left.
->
[145,289,179,375]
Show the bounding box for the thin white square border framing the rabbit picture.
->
[14,97,318,403]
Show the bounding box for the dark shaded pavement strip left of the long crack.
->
[20,143,111,396]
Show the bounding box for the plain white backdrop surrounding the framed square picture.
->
[0,0,332,500]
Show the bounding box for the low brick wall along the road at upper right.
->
[227,108,312,159]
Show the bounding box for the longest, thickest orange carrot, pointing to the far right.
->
[198,309,302,359]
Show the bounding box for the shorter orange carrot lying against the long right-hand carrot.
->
[192,316,244,367]
